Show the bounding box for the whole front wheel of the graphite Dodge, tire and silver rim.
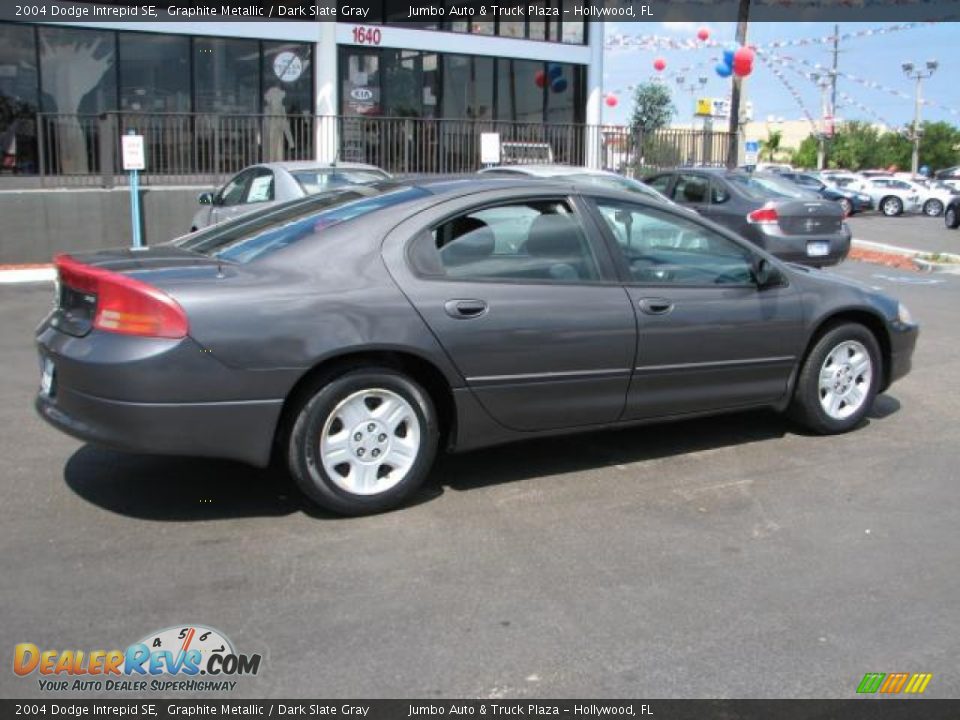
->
[790,323,882,435]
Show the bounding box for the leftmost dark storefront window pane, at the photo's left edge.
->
[0,24,37,173]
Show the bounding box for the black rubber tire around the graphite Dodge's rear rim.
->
[287,368,439,515]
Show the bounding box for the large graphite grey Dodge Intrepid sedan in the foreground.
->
[36,176,918,514]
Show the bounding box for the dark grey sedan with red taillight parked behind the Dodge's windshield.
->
[646,168,851,267]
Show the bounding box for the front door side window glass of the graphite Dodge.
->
[596,200,753,286]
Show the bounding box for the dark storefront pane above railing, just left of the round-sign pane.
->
[193,38,260,114]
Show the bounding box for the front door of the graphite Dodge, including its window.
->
[592,198,803,419]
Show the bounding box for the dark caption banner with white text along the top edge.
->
[0,0,960,23]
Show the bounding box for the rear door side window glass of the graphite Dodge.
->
[412,200,600,283]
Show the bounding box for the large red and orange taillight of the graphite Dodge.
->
[54,255,189,338]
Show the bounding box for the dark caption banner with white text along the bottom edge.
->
[0,698,960,720]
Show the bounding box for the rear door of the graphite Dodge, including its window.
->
[385,190,636,431]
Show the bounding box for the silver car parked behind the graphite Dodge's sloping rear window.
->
[190,160,390,232]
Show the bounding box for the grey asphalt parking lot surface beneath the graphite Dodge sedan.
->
[0,258,960,698]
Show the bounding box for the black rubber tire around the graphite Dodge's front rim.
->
[788,323,883,435]
